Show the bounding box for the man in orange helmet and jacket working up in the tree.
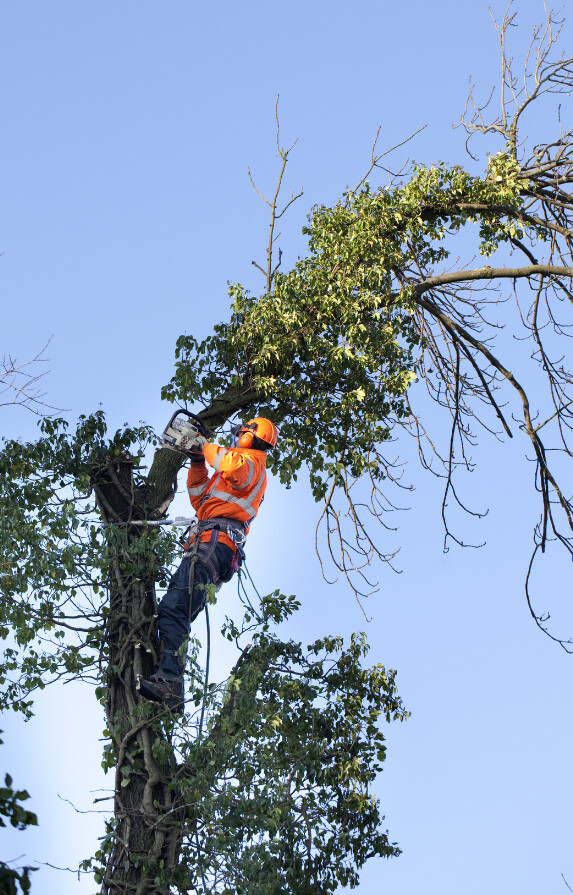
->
[140,417,278,711]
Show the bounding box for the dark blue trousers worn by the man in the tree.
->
[155,544,234,680]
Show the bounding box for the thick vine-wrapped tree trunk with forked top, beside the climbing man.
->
[92,383,258,895]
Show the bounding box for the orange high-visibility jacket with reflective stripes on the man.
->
[187,444,267,550]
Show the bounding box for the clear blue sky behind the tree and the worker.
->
[0,0,573,895]
